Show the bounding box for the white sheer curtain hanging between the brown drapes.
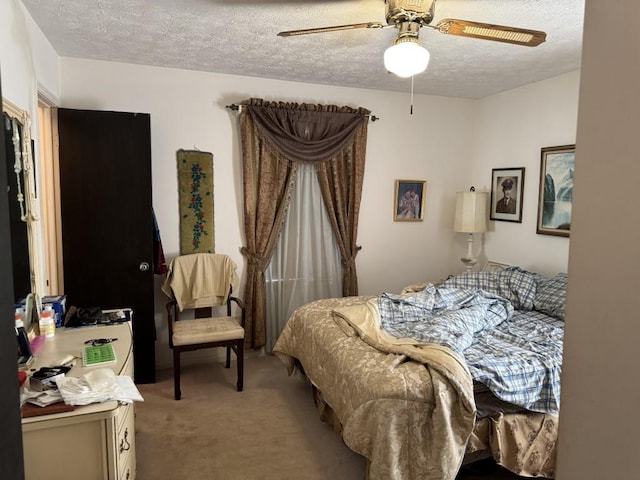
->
[265,163,342,352]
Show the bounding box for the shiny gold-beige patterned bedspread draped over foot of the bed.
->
[274,297,557,480]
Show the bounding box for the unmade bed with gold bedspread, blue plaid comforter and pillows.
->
[274,267,567,480]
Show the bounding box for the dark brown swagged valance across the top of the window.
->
[242,98,371,163]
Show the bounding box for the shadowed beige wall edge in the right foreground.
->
[557,0,640,480]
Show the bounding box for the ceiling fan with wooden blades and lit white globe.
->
[278,0,547,77]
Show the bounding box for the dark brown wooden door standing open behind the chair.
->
[58,108,155,383]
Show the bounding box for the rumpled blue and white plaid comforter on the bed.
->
[378,271,564,414]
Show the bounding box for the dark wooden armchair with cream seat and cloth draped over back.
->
[163,254,245,400]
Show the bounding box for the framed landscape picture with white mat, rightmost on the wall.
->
[536,145,576,237]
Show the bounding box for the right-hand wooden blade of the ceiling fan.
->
[433,18,547,47]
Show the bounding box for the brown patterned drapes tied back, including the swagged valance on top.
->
[240,98,370,348]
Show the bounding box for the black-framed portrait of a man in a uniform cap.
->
[490,167,524,223]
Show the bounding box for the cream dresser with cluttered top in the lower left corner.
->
[22,322,136,480]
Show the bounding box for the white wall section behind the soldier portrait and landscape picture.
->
[471,72,580,275]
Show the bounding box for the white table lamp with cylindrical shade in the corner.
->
[453,187,489,272]
